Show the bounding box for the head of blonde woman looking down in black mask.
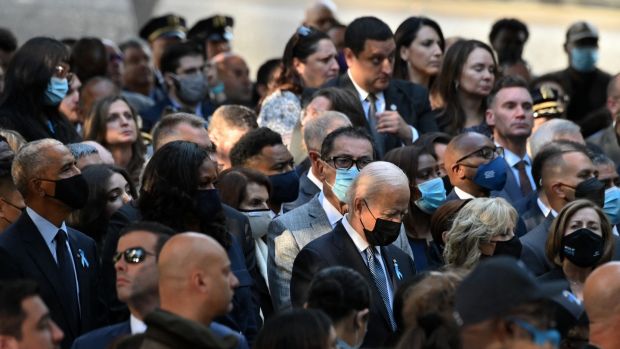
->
[443,198,521,269]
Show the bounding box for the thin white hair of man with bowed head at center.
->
[347,161,409,210]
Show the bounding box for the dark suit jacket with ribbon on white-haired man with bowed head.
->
[291,222,416,348]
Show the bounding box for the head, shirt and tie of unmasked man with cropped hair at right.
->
[486,76,535,205]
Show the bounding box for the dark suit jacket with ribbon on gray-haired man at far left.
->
[0,212,105,348]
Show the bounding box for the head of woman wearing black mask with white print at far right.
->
[539,199,615,299]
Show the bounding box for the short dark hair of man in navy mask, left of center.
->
[230,127,282,167]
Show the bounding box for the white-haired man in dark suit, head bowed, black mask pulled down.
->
[291,161,415,348]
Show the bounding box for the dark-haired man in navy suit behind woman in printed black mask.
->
[521,141,603,276]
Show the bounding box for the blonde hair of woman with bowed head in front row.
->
[443,198,517,269]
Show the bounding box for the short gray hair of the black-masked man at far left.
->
[11,138,64,198]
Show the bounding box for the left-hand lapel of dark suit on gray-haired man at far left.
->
[16,213,79,336]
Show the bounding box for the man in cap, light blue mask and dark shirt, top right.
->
[540,21,611,137]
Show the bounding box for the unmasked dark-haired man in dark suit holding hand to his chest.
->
[326,17,438,157]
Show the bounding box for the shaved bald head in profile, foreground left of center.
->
[157,232,238,325]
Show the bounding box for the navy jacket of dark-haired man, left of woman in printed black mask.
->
[521,214,554,276]
